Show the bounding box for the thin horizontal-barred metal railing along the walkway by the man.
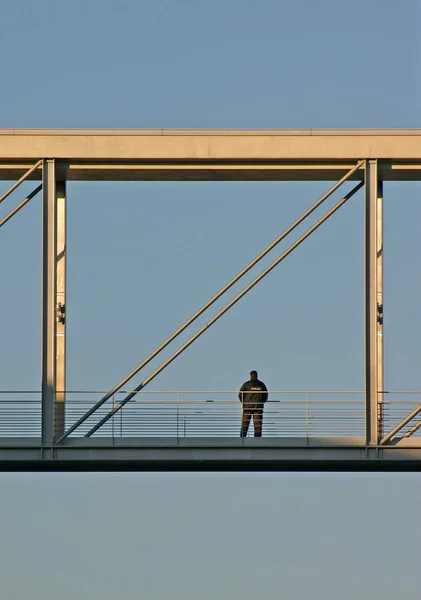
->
[0,390,421,438]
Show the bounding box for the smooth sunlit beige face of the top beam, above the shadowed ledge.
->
[0,129,421,160]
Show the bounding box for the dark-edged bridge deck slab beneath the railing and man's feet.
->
[0,438,421,471]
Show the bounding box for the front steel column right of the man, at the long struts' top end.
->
[365,160,382,446]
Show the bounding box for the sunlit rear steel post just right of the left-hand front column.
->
[54,181,66,438]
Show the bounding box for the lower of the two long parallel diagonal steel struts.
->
[85,182,364,437]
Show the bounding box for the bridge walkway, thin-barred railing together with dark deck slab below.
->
[0,390,421,471]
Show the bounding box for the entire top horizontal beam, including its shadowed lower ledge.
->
[0,129,421,180]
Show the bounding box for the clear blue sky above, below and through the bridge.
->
[0,0,421,600]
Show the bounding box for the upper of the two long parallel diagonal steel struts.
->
[56,160,365,444]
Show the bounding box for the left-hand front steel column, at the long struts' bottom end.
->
[41,160,57,446]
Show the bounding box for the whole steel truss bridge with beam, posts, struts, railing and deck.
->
[0,130,421,471]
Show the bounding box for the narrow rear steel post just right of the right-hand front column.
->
[376,181,384,440]
